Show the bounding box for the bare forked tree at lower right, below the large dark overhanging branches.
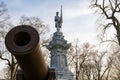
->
[94,52,113,80]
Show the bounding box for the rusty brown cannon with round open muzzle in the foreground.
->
[5,25,55,80]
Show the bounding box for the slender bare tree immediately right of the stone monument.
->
[67,40,84,80]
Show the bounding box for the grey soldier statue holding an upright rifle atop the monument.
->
[55,6,63,32]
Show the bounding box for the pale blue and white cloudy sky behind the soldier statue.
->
[0,0,100,75]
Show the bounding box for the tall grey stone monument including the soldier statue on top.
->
[47,6,75,80]
